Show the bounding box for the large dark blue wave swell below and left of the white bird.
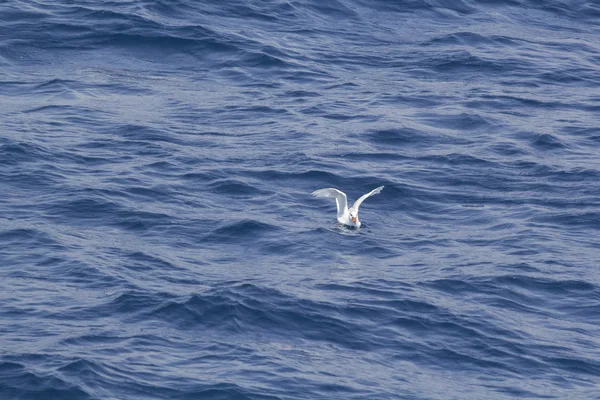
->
[135,284,384,349]
